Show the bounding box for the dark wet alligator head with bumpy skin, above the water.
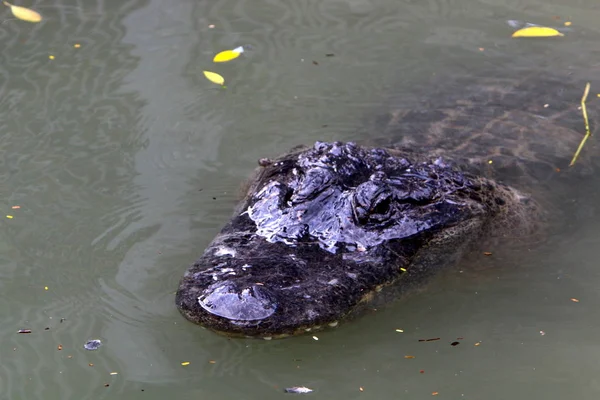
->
[176,142,538,337]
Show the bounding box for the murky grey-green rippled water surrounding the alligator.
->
[0,0,600,399]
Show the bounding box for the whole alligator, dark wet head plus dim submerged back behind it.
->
[176,72,596,338]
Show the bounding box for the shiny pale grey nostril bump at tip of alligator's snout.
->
[198,283,277,321]
